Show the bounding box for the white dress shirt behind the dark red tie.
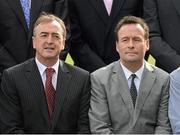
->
[35,58,60,90]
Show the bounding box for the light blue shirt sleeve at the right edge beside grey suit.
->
[169,68,180,134]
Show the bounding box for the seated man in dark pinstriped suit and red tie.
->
[0,14,90,134]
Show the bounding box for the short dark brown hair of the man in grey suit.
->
[115,16,149,41]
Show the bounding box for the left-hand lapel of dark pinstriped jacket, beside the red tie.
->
[26,59,49,123]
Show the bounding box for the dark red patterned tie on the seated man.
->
[45,68,55,121]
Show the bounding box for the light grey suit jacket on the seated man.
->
[89,61,171,134]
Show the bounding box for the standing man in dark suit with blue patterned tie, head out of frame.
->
[0,0,67,82]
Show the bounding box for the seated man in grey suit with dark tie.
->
[89,16,171,134]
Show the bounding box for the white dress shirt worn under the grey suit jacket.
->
[120,62,144,93]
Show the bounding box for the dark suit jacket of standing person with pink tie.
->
[68,0,142,72]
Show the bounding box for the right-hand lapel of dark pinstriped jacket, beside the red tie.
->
[52,61,71,131]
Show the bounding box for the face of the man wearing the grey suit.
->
[116,24,149,64]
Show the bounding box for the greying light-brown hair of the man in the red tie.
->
[33,12,66,39]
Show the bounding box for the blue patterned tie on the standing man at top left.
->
[20,0,31,28]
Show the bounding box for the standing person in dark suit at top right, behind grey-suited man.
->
[144,0,180,73]
